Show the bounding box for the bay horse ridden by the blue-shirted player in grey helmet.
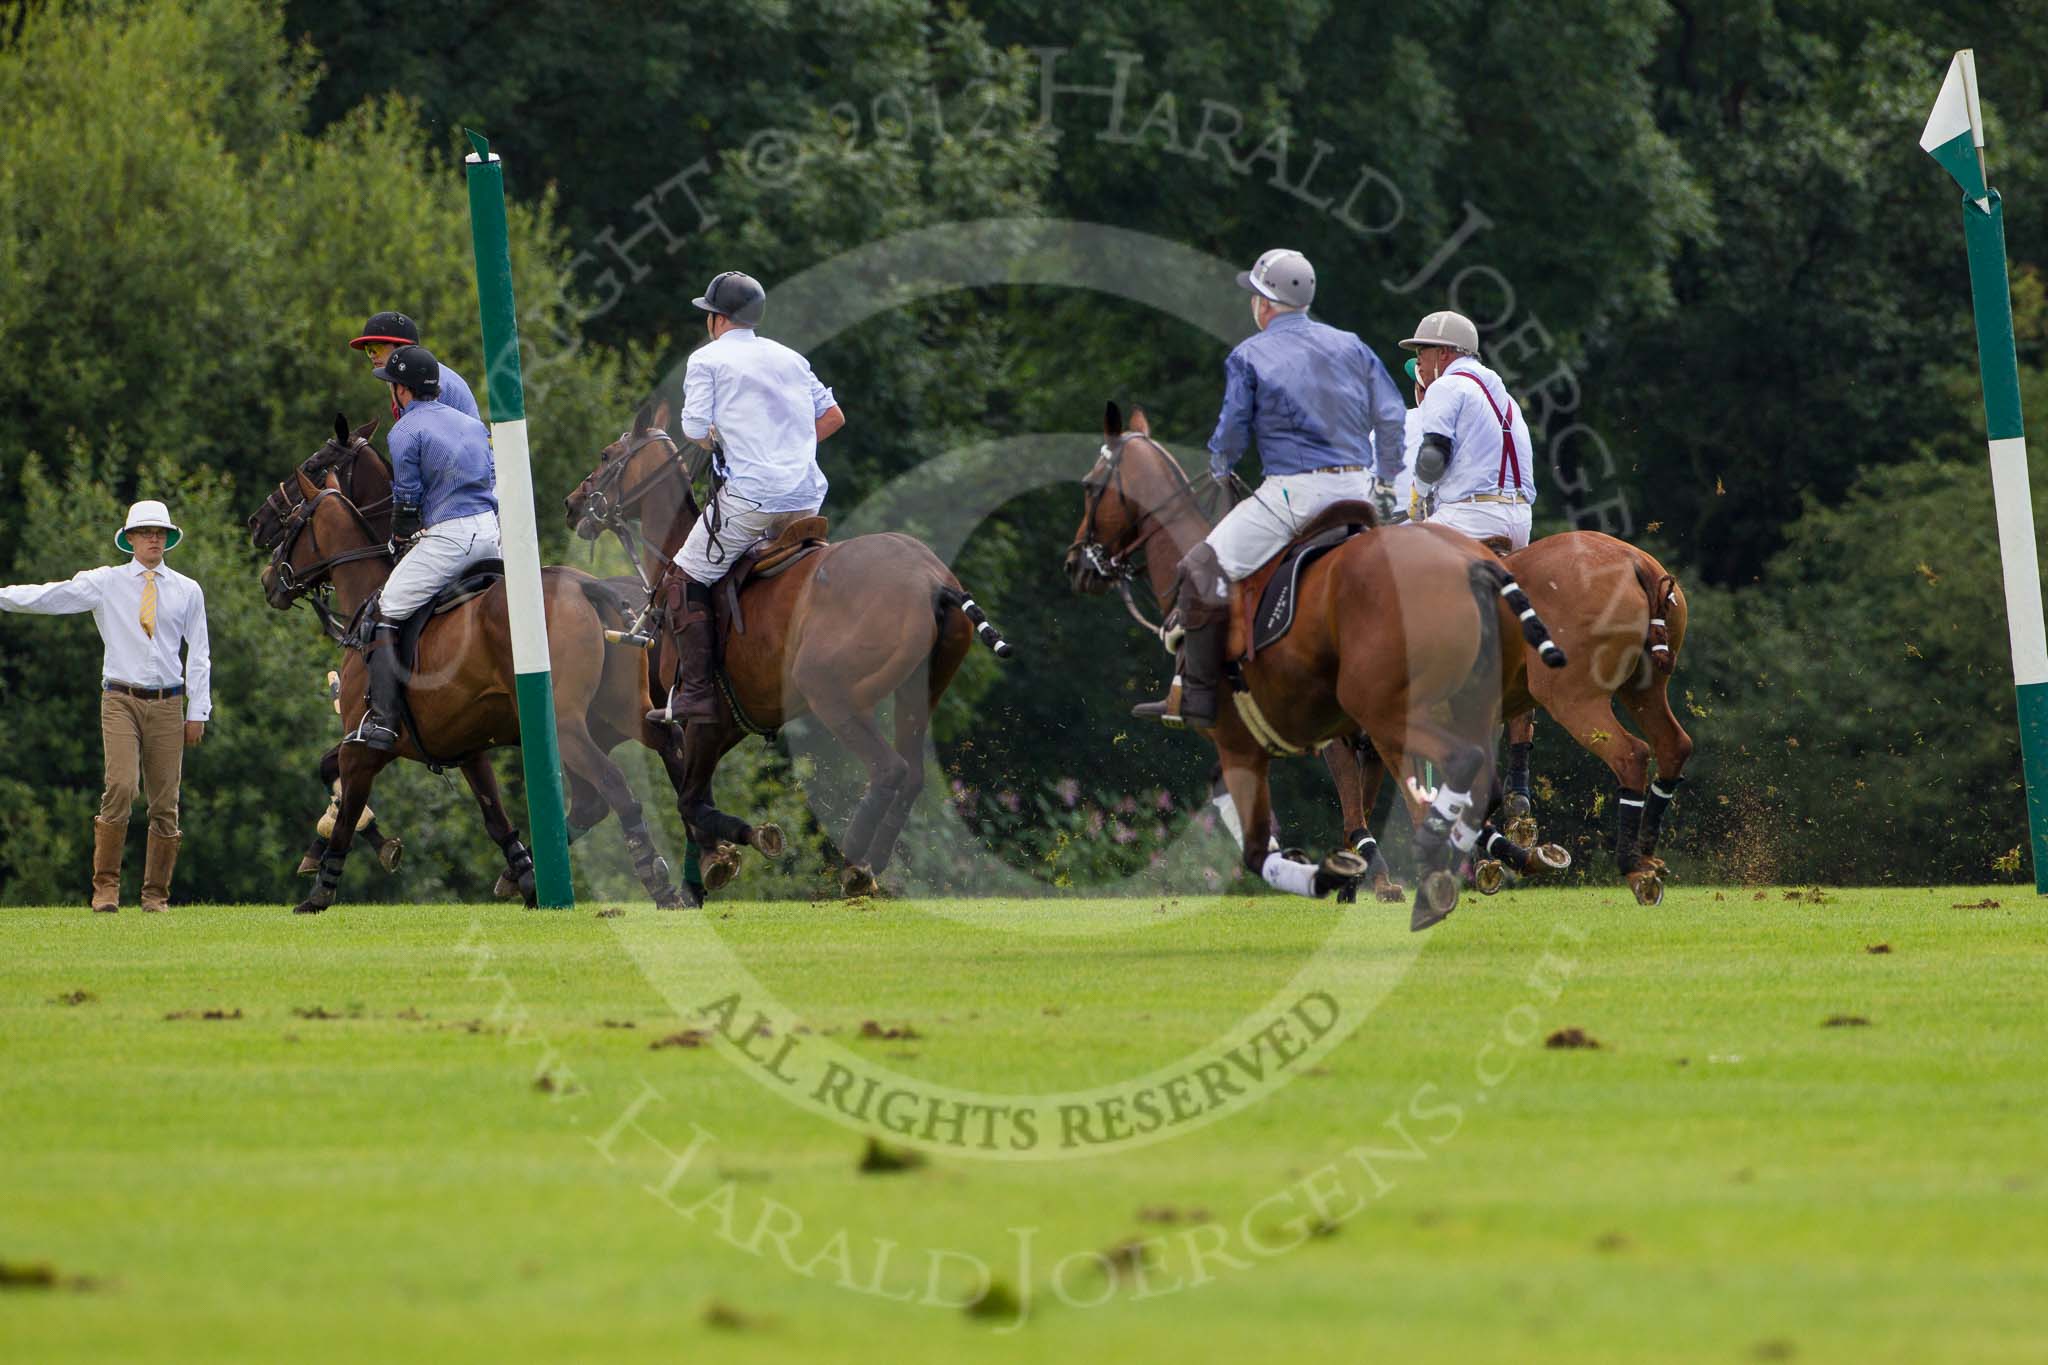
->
[1065,403,1569,929]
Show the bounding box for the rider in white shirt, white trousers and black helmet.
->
[647,270,846,724]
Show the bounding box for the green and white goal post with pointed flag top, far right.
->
[1921,47,2048,894]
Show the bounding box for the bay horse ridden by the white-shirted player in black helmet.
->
[563,399,1012,896]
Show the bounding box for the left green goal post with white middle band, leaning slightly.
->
[463,129,575,909]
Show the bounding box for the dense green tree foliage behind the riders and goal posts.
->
[12,0,2048,900]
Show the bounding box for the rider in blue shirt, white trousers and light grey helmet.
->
[1133,250,1407,729]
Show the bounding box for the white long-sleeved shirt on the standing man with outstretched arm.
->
[0,559,213,720]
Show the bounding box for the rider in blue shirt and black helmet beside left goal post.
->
[344,346,500,753]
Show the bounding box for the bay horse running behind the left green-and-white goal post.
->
[250,422,684,915]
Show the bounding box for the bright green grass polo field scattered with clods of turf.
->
[0,888,2048,1363]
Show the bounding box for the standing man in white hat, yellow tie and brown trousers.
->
[0,501,213,913]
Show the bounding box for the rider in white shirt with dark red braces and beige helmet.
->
[1401,309,1536,555]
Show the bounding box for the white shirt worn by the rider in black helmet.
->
[682,327,838,512]
